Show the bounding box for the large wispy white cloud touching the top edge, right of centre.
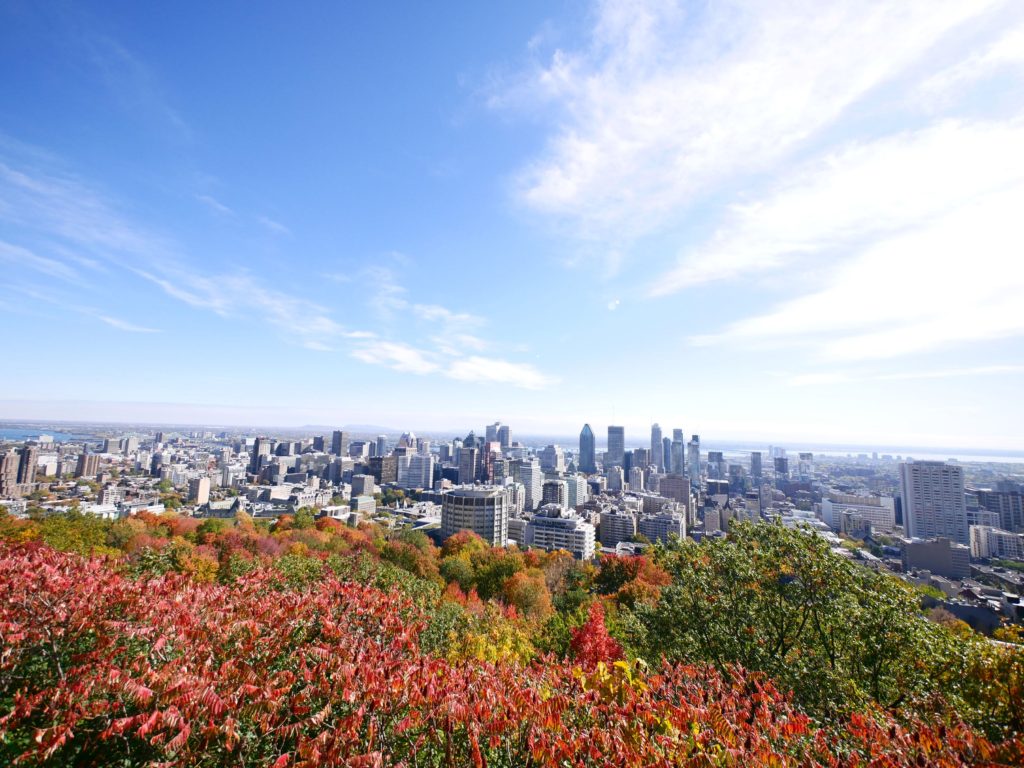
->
[497,0,998,247]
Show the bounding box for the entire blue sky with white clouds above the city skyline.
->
[0,0,1024,450]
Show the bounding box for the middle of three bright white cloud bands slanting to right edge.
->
[649,118,1024,296]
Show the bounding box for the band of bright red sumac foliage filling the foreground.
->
[0,544,1024,768]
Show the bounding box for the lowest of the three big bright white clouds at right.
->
[694,182,1024,360]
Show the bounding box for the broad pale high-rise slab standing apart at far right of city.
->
[899,462,970,545]
